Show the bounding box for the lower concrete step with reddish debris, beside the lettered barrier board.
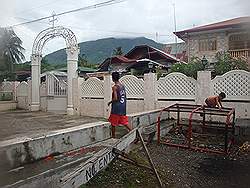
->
[0,139,115,187]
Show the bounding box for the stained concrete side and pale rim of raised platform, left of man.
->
[0,121,110,170]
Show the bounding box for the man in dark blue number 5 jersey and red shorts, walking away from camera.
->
[108,72,132,138]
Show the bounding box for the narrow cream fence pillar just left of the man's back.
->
[103,74,112,118]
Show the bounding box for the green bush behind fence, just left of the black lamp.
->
[171,57,204,78]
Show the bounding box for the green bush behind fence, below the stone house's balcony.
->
[214,52,249,75]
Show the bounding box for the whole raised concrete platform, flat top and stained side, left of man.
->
[0,111,110,170]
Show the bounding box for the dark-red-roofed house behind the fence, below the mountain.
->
[99,45,181,74]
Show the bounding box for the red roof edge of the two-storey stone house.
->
[174,16,250,38]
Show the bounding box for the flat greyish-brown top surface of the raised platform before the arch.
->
[0,110,103,141]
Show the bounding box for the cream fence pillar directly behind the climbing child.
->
[195,71,213,104]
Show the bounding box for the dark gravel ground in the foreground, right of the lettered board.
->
[83,140,250,188]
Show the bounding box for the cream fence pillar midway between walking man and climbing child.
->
[144,73,157,110]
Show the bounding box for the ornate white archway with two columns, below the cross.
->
[30,26,79,115]
